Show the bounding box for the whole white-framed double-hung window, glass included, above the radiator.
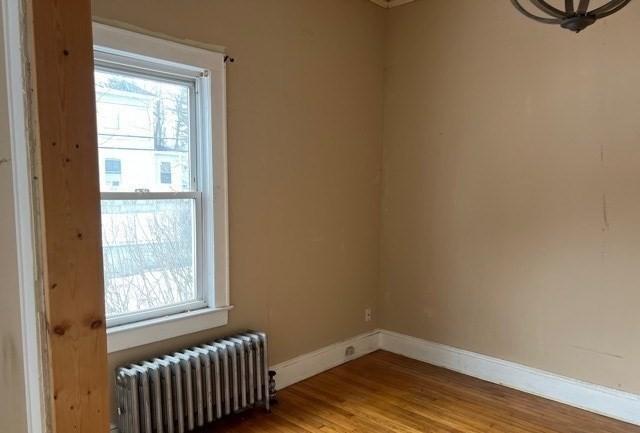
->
[94,24,229,351]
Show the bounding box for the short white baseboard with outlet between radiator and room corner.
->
[271,330,380,389]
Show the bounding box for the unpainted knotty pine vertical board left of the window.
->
[28,0,109,433]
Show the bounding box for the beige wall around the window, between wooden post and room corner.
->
[94,0,385,414]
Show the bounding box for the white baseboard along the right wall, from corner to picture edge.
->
[380,330,640,425]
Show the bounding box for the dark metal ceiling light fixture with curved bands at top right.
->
[511,0,631,33]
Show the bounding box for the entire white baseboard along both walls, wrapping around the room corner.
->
[114,329,640,431]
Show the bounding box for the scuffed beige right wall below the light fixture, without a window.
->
[380,0,640,392]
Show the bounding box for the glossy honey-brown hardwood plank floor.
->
[207,351,640,433]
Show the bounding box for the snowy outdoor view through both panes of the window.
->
[95,65,206,323]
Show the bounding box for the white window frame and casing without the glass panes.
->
[93,23,232,353]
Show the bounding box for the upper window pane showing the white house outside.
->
[95,69,193,192]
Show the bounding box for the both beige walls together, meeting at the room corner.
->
[94,0,640,416]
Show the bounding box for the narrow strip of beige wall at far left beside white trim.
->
[0,8,27,433]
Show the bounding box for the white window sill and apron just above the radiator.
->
[107,306,233,353]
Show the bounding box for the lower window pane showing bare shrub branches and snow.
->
[102,199,198,317]
